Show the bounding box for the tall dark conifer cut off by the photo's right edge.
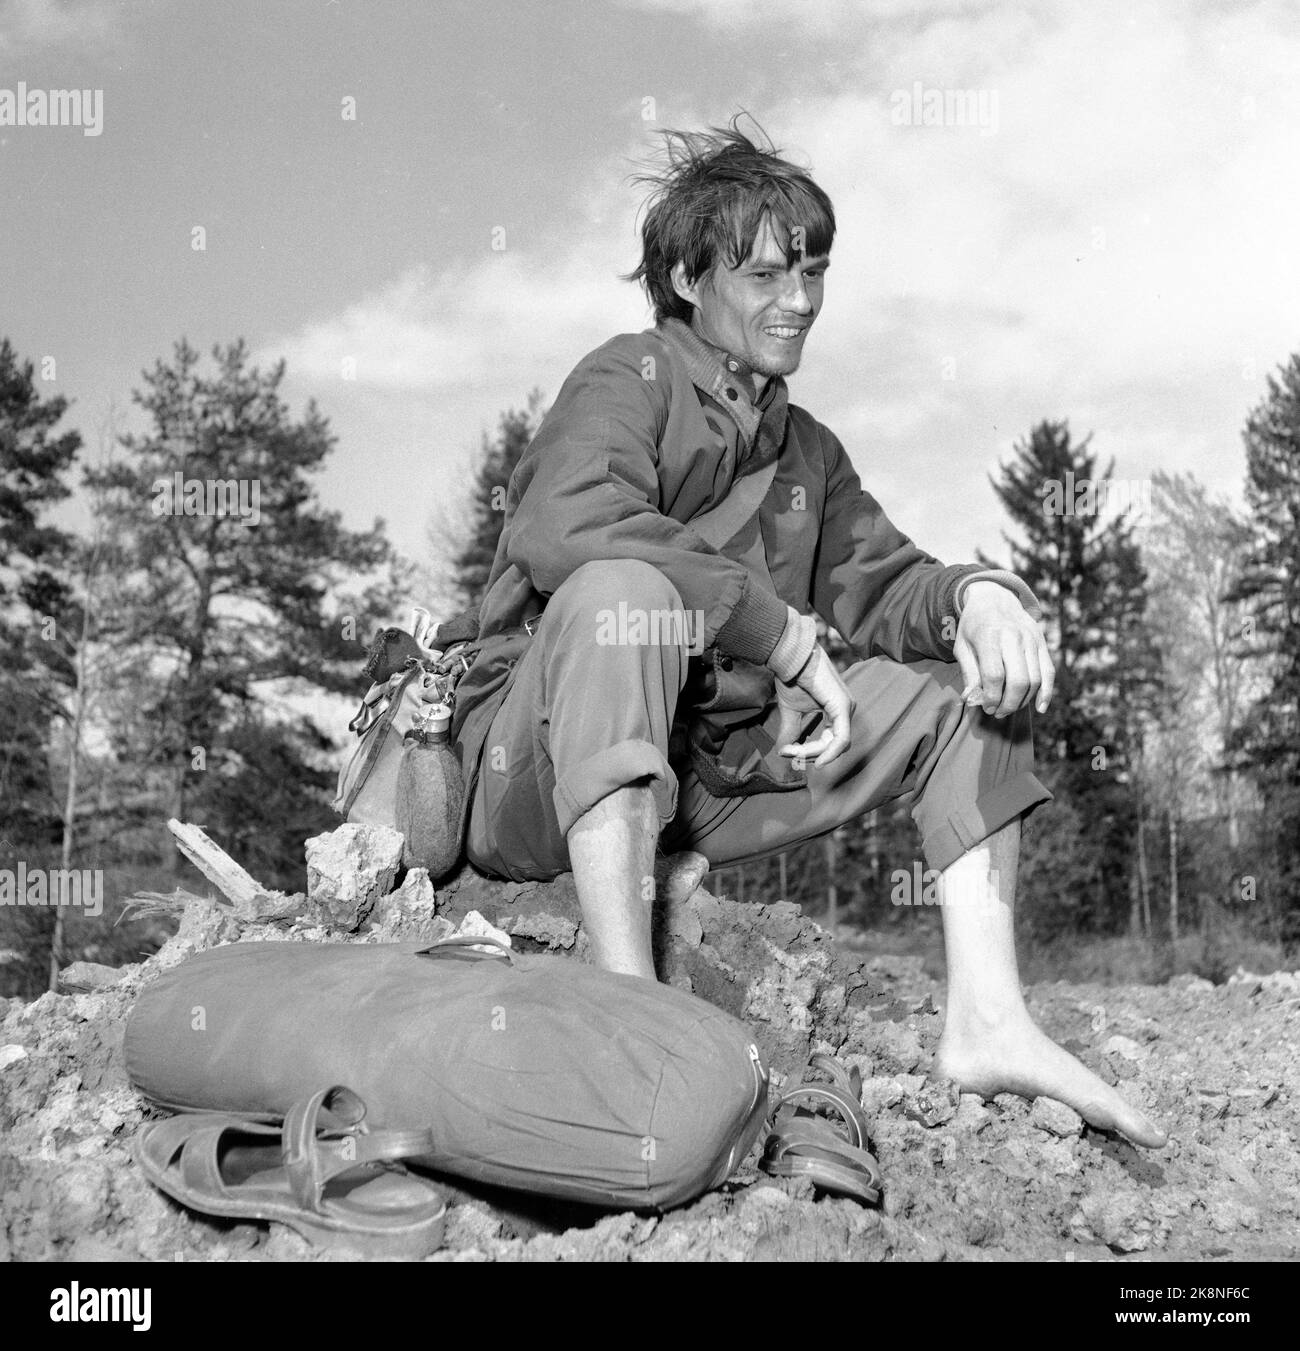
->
[1230,354,1300,939]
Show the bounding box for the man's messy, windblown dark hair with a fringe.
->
[624,113,835,323]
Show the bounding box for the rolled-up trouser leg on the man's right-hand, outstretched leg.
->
[662,657,1051,870]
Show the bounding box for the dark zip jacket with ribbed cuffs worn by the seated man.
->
[453,320,981,799]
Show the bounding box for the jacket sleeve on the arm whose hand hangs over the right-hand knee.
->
[812,427,981,662]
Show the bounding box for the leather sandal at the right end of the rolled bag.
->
[758,1055,881,1205]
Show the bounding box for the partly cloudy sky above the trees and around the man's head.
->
[0,0,1300,580]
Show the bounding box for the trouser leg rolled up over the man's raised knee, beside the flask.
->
[466,559,693,881]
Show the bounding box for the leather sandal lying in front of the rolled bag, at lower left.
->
[135,1085,447,1258]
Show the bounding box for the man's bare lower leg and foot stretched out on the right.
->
[932,820,1165,1148]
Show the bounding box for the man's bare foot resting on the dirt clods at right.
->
[930,1009,1168,1150]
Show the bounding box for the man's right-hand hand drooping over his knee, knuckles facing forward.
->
[953,582,1055,717]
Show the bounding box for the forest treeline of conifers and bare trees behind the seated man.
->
[0,340,1300,994]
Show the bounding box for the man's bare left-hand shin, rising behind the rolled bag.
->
[566,786,659,981]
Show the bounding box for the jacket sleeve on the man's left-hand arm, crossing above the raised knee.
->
[504,335,788,663]
